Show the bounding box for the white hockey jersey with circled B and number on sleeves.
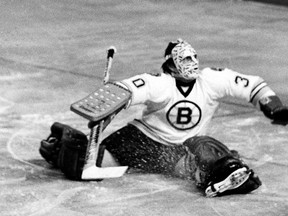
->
[121,68,275,145]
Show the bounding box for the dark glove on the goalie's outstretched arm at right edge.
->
[259,95,288,125]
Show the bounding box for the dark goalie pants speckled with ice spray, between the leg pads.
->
[101,124,187,174]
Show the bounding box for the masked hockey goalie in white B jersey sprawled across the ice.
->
[40,39,288,197]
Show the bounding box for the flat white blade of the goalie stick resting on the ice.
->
[81,166,128,180]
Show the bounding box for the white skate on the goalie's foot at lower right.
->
[205,167,251,197]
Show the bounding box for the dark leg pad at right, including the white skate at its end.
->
[184,136,261,197]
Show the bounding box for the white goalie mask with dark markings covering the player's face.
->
[171,39,199,80]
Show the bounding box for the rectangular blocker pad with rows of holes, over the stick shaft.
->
[70,83,131,122]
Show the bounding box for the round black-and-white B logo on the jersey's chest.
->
[166,100,202,130]
